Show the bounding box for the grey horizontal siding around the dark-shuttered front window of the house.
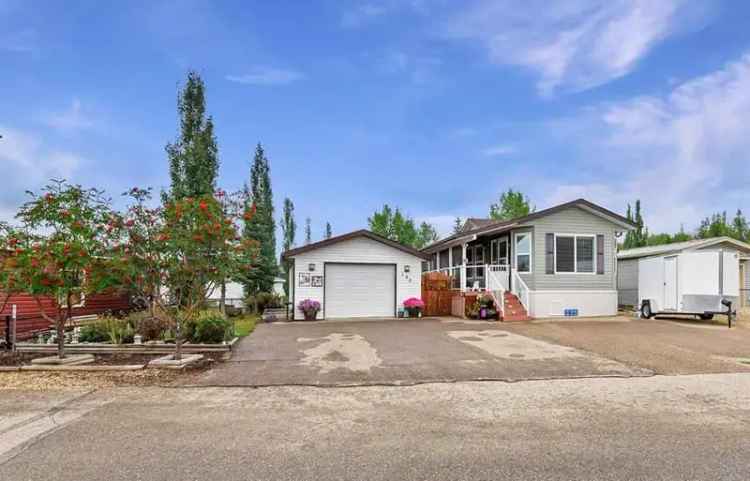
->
[524,207,618,290]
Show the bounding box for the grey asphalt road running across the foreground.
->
[0,374,750,481]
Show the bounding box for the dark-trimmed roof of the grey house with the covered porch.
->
[422,199,635,252]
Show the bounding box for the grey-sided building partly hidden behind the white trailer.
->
[617,237,750,307]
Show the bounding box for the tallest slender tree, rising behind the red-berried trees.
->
[166,71,219,199]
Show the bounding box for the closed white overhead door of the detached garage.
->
[324,264,396,319]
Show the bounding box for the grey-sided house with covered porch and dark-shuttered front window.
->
[422,199,634,317]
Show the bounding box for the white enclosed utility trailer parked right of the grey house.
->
[638,250,740,326]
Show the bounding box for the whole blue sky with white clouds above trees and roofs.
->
[0,0,750,239]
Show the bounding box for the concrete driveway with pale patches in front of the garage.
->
[191,318,652,386]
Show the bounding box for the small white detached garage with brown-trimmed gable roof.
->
[282,230,424,320]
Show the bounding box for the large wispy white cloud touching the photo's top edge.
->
[447,0,705,95]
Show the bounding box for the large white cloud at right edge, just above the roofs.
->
[546,53,750,231]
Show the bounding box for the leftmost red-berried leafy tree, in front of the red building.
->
[0,181,119,359]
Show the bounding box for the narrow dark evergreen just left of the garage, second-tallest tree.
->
[243,142,279,294]
